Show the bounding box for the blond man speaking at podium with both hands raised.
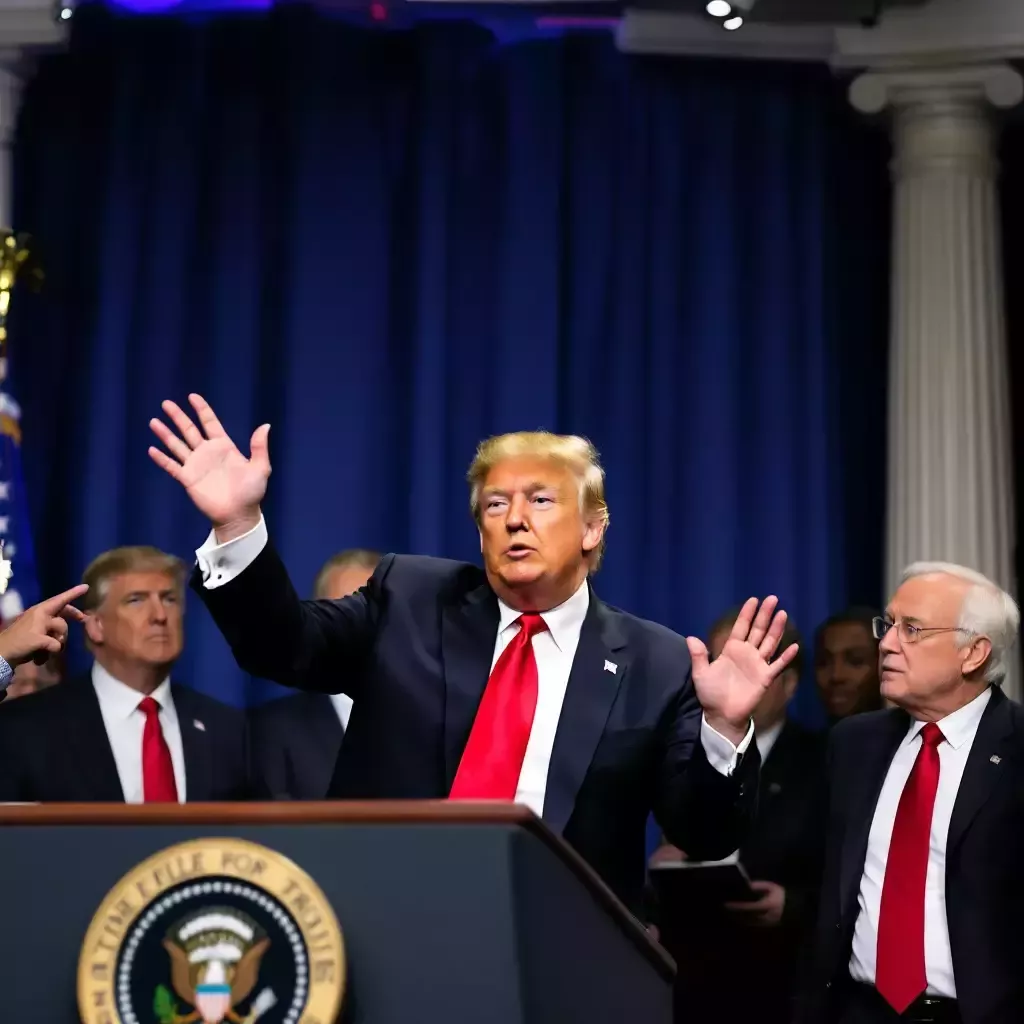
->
[150,394,797,908]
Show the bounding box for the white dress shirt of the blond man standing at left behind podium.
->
[92,662,185,804]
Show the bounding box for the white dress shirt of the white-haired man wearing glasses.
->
[850,688,992,999]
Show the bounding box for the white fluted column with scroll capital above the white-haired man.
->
[850,65,1024,699]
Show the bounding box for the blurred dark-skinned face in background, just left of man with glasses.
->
[814,622,881,719]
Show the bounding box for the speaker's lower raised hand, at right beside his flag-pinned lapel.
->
[686,597,798,742]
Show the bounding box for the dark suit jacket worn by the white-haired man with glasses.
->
[798,689,1024,1024]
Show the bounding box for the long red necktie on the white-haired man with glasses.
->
[874,722,945,1014]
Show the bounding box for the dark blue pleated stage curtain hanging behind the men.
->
[8,9,888,718]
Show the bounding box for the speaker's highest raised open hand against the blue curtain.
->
[150,394,270,544]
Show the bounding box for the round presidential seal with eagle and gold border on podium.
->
[78,839,345,1024]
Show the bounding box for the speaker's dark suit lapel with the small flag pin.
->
[544,590,629,833]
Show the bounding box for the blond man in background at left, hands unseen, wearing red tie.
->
[0,547,250,803]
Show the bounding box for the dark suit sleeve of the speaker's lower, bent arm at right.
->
[653,672,761,860]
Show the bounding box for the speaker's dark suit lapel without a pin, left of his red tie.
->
[441,584,500,796]
